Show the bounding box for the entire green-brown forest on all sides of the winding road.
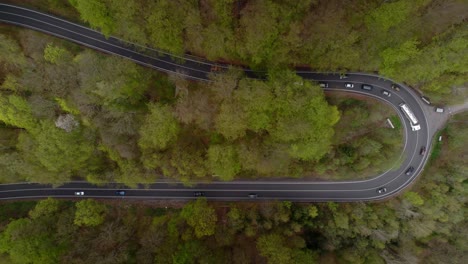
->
[0,0,468,264]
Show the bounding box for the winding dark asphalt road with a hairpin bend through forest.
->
[0,4,433,201]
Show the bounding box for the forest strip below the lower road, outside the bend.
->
[0,114,468,264]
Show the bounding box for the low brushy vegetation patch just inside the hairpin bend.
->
[316,93,403,180]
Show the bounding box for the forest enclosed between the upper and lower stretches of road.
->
[0,26,402,185]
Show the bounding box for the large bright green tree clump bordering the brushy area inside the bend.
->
[269,72,339,160]
